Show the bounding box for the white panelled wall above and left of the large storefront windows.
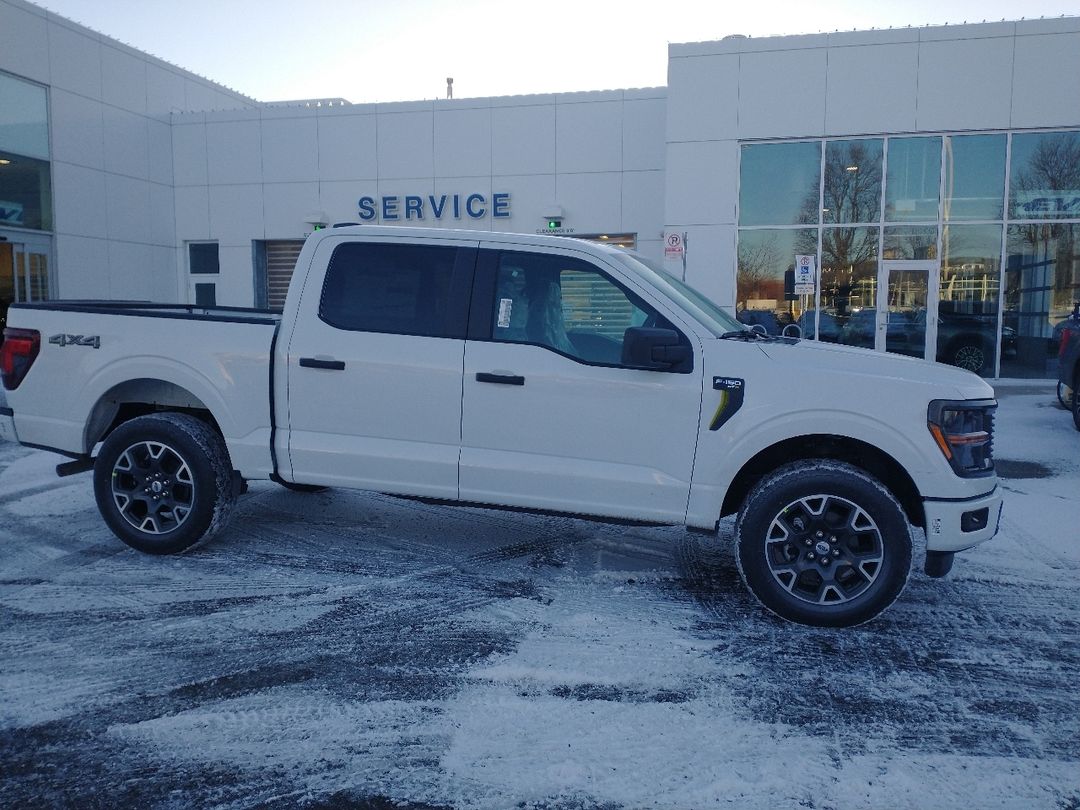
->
[664,17,1080,308]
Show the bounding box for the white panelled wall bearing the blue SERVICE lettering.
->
[172,89,666,306]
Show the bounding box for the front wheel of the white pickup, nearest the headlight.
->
[735,460,912,627]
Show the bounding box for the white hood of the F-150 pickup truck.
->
[757,340,994,400]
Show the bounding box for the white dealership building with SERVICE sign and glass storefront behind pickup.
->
[0,0,1080,378]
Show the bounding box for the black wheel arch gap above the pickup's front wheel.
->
[720,433,924,526]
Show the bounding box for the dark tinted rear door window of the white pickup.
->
[319,242,463,338]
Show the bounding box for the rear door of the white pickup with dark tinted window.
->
[278,237,476,498]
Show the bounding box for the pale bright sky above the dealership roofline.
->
[38,0,1080,103]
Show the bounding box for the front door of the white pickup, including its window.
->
[460,244,702,522]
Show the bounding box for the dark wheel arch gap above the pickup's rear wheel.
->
[83,377,221,449]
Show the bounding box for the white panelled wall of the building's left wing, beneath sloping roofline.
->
[0,0,255,301]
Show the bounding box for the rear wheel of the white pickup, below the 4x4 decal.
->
[94,414,235,554]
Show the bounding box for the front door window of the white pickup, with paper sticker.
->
[491,252,673,365]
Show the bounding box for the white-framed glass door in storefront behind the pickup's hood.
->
[874,260,940,360]
